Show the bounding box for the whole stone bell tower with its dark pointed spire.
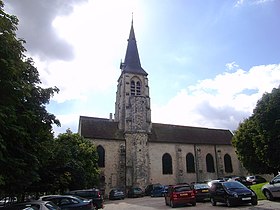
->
[115,20,152,187]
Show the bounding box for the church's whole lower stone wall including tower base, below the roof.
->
[88,137,247,197]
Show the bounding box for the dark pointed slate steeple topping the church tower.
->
[120,19,148,75]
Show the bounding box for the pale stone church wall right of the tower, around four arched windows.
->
[149,142,246,184]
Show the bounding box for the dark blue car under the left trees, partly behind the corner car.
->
[39,195,95,210]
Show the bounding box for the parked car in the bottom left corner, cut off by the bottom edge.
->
[1,201,60,210]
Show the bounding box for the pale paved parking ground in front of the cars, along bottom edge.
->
[104,196,280,210]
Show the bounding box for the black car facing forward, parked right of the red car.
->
[209,181,258,206]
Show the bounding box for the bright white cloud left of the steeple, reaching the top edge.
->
[29,0,144,103]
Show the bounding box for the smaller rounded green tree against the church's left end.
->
[33,129,99,192]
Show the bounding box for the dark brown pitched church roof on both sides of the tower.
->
[79,116,233,145]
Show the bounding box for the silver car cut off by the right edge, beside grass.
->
[262,174,280,200]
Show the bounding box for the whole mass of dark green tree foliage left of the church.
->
[0,0,99,199]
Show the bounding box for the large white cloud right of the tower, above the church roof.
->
[151,64,280,130]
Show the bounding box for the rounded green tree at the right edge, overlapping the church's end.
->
[233,87,280,174]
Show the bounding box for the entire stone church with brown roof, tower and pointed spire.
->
[78,21,246,197]
